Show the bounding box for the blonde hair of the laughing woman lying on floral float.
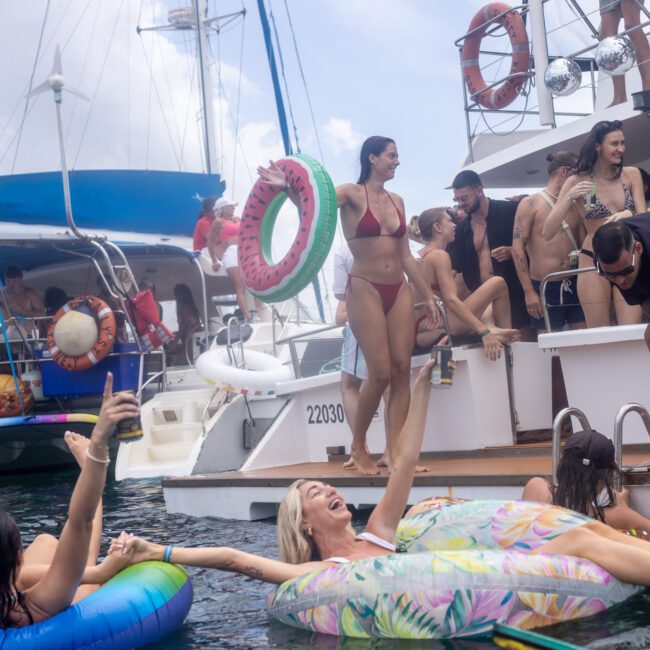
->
[278,478,320,564]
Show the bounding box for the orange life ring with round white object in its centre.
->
[47,296,117,370]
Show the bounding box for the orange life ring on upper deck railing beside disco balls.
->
[461,2,530,109]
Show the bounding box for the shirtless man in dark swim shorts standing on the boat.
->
[512,151,585,331]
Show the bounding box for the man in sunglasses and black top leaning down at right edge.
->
[593,213,650,350]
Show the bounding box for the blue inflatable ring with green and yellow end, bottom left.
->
[0,562,192,650]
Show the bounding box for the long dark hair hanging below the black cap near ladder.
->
[553,453,620,521]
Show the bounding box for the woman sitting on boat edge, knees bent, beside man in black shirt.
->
[415,208,519,360]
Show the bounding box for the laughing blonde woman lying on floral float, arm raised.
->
[114,360,650,585]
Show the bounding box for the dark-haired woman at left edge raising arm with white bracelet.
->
[0,373,139,628]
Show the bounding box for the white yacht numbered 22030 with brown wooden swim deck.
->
[161,0,650,519]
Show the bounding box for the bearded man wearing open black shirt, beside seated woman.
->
[449,170,530,339]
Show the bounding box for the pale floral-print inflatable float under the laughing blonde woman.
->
[268,499,640,639]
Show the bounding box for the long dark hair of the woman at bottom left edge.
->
[0,510,34,629]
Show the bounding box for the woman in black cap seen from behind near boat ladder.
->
[521,431,650,531]
